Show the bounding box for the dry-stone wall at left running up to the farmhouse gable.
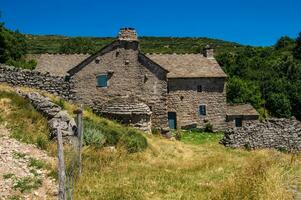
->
[0,64,75,100]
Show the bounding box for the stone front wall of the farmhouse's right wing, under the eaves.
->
[167,78,226,131]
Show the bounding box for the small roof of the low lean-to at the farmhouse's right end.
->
[226,104,259,116]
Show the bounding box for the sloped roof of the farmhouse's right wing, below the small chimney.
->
[146,54,227,78]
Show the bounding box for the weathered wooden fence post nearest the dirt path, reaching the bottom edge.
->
[57,128,66,200]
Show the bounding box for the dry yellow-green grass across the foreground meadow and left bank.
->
[0,83,301,200]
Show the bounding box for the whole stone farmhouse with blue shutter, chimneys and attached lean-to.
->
[26,28,258,131]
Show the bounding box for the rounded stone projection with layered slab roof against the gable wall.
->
[100,103,152,133]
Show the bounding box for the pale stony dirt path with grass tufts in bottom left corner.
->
[0,125,57,200]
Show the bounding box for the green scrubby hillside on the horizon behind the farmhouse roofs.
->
[26,35,242,54]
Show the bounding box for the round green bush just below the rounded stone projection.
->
[120,129,147,153]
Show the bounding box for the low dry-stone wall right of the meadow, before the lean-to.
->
[221,118,301,152]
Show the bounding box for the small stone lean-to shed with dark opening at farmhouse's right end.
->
[226,104,259,128]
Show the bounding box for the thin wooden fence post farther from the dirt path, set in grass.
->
[74,109,84,175]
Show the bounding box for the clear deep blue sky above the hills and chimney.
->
[0,0,301,46]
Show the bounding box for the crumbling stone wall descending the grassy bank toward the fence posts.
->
[19,92,77,139]
